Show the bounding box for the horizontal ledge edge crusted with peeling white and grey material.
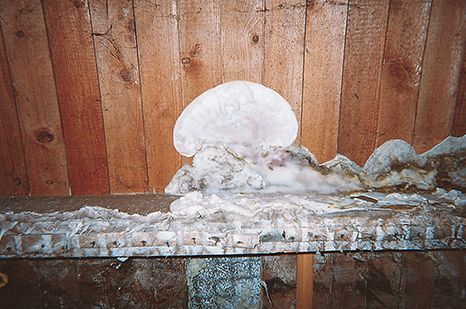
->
[0,190,466,257]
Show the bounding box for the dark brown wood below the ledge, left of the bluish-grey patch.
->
[0,258,188,308]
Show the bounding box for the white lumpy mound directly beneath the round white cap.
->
[165,147,362,195]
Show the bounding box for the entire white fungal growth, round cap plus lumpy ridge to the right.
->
[165,81,466,195]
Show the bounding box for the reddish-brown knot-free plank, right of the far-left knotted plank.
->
[43,0,109,195]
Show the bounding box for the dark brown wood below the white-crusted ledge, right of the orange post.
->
[313,250,465,308]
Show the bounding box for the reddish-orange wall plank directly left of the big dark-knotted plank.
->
[338,0,389,165]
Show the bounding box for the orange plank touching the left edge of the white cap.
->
[134,0,183,192]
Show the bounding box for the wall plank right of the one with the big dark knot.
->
[413,0,466,152]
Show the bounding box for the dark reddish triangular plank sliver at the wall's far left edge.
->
[0,27,29,195]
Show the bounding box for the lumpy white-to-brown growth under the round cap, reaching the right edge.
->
[165,135,466,195]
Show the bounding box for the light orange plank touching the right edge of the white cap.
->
[301,0,348,162]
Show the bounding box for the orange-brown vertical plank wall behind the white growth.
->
[0,0,466,195]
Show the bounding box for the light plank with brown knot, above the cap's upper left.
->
[179,0,223,105]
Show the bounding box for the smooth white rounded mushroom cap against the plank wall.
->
[173,81,298,157]
